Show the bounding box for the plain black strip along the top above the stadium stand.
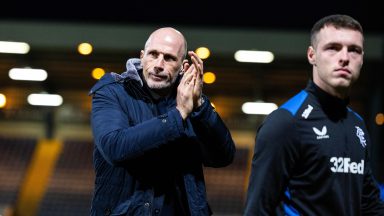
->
[0,0,384,33]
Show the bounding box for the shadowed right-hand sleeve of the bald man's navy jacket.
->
[190,95,236,167]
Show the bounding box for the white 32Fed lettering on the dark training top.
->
[329,157,364,175]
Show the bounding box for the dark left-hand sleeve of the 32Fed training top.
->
[244,109,300,216]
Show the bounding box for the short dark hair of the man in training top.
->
[311,14,363,46]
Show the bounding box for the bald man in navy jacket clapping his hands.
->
[90,28,235,216]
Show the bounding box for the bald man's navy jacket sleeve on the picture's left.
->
[91,83,186,165]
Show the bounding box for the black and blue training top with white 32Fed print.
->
[244,81,384,216]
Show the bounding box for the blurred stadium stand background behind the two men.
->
[0,1,384,216]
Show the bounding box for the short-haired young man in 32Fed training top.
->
[244,15,384,216]
